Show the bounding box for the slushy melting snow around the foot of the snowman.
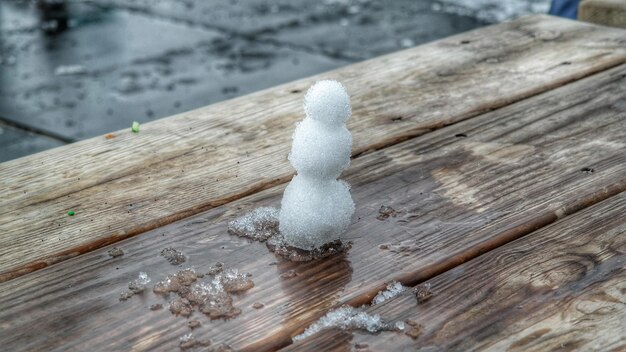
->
[228,207,352,262]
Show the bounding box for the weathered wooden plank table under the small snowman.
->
[0,16,626,351]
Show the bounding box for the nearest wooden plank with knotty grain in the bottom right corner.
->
[286,193,626,351]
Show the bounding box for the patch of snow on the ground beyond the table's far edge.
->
[432,0,550,23]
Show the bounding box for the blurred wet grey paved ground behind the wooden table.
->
[0,0,550,162]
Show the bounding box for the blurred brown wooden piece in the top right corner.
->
[578,0,626,28]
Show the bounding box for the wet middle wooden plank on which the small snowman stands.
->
[0,65,626,351]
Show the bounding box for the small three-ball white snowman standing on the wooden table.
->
[279,80,354,250]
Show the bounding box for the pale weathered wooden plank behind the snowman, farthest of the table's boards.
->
[0,16,626,281]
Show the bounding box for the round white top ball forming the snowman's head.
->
[304,80,352,126]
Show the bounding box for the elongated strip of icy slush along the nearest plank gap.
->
[293,306,392,341]
